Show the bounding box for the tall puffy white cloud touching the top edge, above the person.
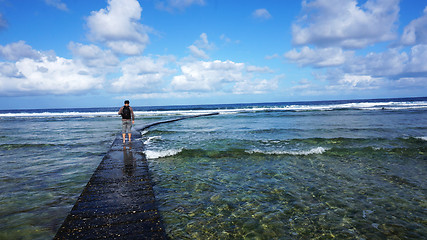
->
[87,0,151,55]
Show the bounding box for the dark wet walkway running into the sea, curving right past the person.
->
[53,112,219,240]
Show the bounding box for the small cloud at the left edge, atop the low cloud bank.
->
[0,41,41,61]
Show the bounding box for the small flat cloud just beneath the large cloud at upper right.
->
[285,46,353,67]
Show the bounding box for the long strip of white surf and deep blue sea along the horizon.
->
[0,98,427,118]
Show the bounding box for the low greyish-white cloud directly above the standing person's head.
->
[111,57,175,93]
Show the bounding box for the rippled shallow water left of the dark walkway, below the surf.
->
[0,117,117,239]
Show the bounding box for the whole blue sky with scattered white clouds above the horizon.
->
[0,0,427,109]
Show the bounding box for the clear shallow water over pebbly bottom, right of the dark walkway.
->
[146,107,427,239]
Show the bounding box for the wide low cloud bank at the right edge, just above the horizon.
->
[294,45,427,95]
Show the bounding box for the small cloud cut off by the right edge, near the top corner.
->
[401,7,427,45]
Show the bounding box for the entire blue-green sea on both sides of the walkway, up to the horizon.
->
[0,98,427,239]
